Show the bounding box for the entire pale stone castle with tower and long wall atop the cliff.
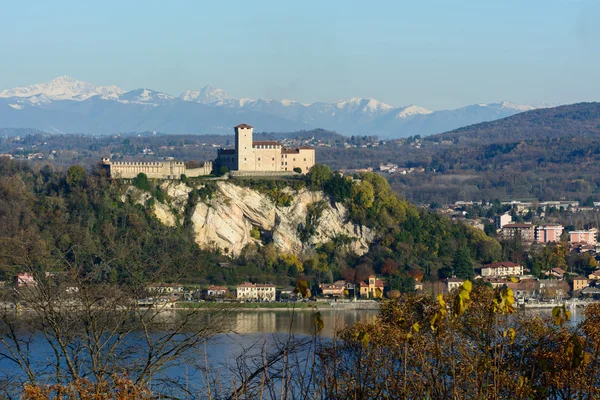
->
[102,124,315,179]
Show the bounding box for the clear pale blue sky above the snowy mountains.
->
[0,0,600,109]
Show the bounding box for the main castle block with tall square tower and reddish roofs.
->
[215,124,315,175]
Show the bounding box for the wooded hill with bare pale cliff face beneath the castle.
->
[0,158,501,286]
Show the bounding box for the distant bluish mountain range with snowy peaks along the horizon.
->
[0,76,552,138]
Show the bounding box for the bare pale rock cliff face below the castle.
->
[131,181,375,256]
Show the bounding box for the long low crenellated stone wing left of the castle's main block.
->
[102,158,213,179]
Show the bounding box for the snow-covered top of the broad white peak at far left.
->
[0,76,123,103]
